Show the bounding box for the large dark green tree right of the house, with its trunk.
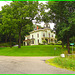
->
[42,1,75,53]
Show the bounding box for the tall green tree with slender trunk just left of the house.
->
[11,1,38,48]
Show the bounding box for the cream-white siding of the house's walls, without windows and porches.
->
[25,29,55,45]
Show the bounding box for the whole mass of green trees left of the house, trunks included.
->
[0,1,38,48]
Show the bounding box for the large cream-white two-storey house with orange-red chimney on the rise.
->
[23,25,57,46]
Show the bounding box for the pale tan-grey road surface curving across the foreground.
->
[0,56,75,74]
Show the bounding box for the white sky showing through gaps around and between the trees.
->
[0,1,54,29]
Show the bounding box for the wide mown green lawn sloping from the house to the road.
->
[0,45,74,56]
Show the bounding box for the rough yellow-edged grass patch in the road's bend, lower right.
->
[46,56,75,71]
